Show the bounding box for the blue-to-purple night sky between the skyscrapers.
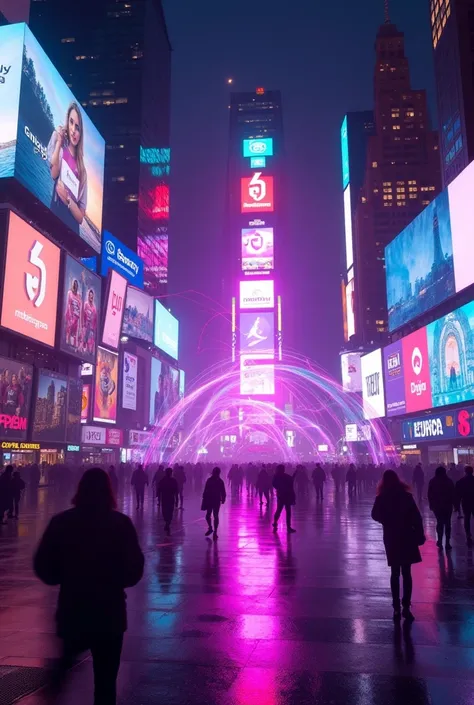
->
[163,0,436,378]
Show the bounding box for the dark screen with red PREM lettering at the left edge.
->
[0,357,33,440]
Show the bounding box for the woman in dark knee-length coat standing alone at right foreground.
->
[372,470,426,621]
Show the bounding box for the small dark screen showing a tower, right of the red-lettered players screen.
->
[32,370,68,443]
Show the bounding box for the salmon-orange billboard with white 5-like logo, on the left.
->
[0,212,60,347]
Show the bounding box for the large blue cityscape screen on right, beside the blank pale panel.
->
[385,191,455,331]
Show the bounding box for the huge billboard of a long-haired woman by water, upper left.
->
[0,24,105,252]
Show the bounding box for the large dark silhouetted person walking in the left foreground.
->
[34,468,144,705]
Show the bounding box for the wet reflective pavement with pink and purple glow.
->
[0,482,474,705]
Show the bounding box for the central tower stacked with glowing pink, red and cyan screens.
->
[224,88,284,442]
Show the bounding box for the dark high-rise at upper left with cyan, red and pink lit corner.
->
[30,0,171,294]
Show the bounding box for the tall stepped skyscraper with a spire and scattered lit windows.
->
[346,12,441,346]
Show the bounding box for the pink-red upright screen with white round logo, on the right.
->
[402,328,432,414]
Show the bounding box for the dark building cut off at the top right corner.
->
[430,0,474,187]
